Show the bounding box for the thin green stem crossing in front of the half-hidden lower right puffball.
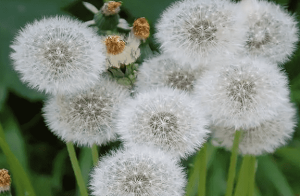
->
[225,130,242,196]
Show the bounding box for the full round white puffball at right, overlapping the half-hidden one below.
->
[194,57,289,129]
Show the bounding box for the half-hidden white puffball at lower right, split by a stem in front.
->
[212,103,297,156]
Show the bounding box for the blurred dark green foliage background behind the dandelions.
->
[0,0,300,196]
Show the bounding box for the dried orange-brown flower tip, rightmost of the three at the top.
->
[132,18,150,40]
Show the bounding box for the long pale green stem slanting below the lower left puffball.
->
[67,142,88,196]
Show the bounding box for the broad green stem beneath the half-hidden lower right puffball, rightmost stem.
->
[234,155,251,196]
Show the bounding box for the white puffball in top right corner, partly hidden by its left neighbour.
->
[240,0,298,63]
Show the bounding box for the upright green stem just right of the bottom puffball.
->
[198,143,207,196]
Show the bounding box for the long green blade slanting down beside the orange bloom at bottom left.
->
[0,124,35,196]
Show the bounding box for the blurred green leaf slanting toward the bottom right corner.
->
[258,156,294,196]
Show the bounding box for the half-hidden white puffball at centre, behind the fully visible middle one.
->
[136,54,207,93]
